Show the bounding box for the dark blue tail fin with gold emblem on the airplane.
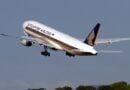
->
[84,23,100,46]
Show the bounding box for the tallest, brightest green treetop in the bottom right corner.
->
[111,81,128,90]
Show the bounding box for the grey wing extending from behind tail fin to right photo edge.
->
[95,38,130,45]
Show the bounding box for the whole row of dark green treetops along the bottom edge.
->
[28,81,130,90]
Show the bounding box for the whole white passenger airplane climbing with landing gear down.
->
[1,20,130,57]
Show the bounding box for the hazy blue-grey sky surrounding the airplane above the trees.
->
[0,0,130,90]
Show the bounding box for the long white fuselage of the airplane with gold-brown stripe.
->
[23,21,97,55]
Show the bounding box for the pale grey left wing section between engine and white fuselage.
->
[21,36,54,48]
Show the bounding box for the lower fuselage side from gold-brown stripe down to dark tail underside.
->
[25,27,91,55]
